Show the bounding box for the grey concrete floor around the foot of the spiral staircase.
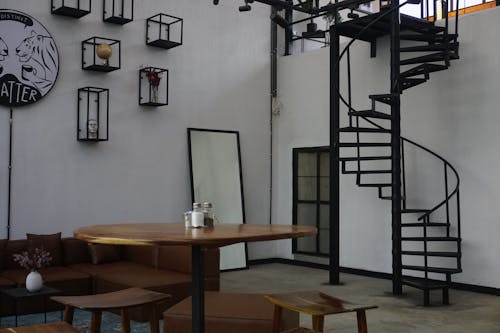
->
[221,264,500,333]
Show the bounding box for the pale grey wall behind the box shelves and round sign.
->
[0,0,273,252]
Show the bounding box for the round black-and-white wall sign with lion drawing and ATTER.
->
[0,9,59,107]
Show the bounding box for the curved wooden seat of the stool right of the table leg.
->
[265,291,377,316]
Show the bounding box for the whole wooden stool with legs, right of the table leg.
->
[266,291,377,333]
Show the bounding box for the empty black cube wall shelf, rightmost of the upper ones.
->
[146,14,184,49]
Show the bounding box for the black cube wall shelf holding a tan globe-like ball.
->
[82,37,122,72]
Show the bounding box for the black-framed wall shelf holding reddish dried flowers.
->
[139,66,168,106]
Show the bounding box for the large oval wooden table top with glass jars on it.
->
[74,223,317,246]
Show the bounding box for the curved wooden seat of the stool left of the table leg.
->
[51,288,171,308]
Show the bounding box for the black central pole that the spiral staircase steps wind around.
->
[391,0,403,295]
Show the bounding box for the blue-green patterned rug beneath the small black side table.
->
[0,310,163,333]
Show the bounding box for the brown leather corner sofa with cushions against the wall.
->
[0,234,219,321]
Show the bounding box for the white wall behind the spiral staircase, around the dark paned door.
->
[273,8,500,288]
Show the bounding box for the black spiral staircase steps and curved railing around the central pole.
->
[334,2,462,305]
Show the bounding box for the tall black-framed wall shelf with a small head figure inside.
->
[76,87,109,142]
